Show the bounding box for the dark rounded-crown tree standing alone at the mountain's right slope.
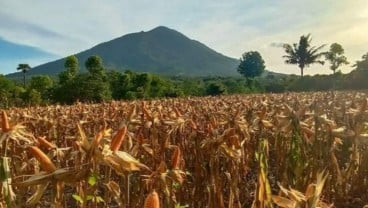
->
[238,51,266,88]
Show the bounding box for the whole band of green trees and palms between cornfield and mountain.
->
[0,35,368,108]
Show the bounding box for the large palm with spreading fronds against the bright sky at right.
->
[283,34,325,77]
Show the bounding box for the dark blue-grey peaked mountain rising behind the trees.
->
[9,26,239,77]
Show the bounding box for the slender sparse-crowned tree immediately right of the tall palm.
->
[325,43,349,74]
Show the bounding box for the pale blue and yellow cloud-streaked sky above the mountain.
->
[0,0,368,74]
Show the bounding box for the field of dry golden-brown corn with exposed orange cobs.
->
[0,92,368,208]
